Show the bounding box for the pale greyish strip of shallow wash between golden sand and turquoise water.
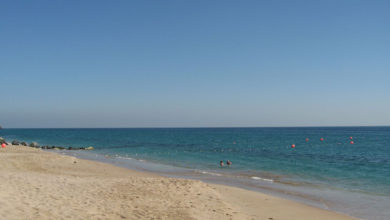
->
[52,150,387,219]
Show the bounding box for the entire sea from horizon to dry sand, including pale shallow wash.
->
[0,127,390,219]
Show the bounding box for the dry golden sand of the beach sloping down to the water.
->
[0,145,353,220]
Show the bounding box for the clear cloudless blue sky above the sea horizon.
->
[0,0,390,127]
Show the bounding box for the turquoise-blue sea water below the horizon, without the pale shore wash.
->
[0,127,390,219]
